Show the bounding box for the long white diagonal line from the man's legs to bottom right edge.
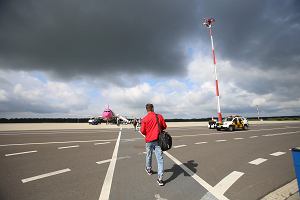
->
[164,151,228,200]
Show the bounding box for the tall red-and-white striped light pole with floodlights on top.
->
[203,18,222,123]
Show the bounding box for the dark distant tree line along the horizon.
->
[0,116,300,123]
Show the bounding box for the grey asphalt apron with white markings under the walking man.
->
[0,123,300,200]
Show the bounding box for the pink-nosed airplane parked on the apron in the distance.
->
[88,106,130,125]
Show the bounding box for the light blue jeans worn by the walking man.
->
[146,141,164,178]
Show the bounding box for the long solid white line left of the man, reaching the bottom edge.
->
[99,128,122,200]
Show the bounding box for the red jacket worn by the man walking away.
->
[140,112,167,142]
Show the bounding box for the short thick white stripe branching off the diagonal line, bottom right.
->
[214,171,244,194]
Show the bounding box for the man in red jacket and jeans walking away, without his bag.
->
[140,103,167,186]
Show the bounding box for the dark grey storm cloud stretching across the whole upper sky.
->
[0,0,300,79]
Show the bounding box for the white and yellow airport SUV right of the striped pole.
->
[217,115,249,131]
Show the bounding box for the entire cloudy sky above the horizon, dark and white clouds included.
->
[0,0,300,118]
